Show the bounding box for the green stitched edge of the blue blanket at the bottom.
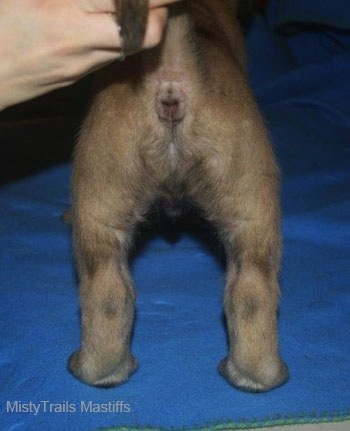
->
[95,410,350,431]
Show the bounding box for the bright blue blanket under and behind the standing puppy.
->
[0,0,350,431]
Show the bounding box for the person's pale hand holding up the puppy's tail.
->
[0,0,183,110]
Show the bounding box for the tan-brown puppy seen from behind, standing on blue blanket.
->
[69,0,288,391]
